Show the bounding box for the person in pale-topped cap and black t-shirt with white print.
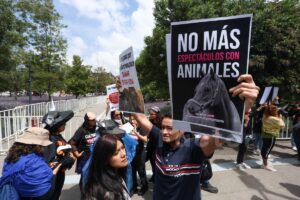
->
[68,112,97,196]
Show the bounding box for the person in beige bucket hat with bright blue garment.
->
[0,127,60,200]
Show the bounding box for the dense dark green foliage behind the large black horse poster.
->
[136,0,300,100]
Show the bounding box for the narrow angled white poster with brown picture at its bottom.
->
[118,47,145,113]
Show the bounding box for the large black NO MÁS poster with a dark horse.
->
[167,15,252,142]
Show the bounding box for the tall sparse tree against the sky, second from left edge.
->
[17,0,67,100]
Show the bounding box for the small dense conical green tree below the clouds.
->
[65,55,91,98]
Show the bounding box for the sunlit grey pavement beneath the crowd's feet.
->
[0,103,300,200]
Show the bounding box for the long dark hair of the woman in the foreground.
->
[84,134,126,200]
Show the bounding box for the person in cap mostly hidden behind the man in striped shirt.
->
[146,106,161,182]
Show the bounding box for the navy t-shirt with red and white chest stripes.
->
[150,126,207,200]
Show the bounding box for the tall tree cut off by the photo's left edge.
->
[0,0,26,99]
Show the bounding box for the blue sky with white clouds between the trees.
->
[54,0,154,75]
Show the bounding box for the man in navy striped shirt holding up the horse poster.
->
[135,74,259,200]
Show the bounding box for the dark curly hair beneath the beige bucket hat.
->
[5,142,44,163]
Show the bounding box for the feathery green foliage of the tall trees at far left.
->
[0,0,66,99]
